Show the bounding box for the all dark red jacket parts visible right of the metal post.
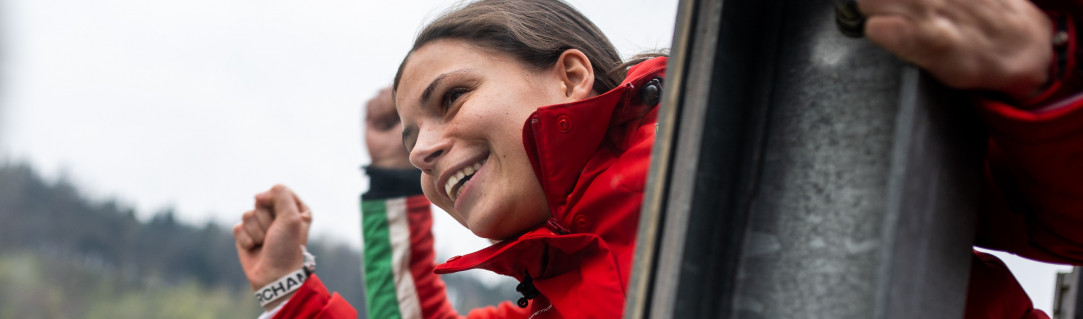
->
[966,8,1083,319]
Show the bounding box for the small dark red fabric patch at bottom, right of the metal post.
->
[964,251,1049,319]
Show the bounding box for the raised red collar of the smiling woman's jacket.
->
[434,57,666,280]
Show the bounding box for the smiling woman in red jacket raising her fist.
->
[234,0,666,318]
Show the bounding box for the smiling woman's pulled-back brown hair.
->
[393,0,627,93]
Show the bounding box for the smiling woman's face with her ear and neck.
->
[395,40,574,239]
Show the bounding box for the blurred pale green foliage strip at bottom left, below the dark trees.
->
[0,252,260,319]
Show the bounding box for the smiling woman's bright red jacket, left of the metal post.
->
[275,57,666,319]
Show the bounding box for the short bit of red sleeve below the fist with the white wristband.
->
[274,275,357,319]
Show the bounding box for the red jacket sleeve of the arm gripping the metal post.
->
[976,8,1083,265]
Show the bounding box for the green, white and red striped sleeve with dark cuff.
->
[362,168,525,318]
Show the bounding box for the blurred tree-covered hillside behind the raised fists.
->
[0,164,514,319]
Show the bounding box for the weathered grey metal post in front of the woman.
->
[626,0,984,318]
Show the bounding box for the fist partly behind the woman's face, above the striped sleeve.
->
[365,88,414,169]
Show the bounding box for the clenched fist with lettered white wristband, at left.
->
[233,185,312,309]
